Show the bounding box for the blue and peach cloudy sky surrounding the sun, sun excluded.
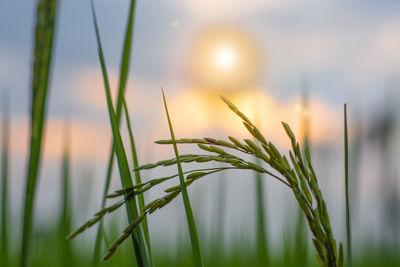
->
[0,0,400,247]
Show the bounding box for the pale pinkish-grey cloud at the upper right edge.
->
[330,17,400,92]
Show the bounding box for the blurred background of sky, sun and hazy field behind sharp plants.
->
[0,0,400,266]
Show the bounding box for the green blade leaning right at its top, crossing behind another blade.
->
[93,0,144,266]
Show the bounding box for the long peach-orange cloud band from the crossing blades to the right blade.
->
[64,64,341,149]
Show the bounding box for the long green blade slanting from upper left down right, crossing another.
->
[91,1,148,267]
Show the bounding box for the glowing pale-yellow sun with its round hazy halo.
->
[190,27,261,91]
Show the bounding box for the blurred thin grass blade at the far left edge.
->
[0,92,10,266]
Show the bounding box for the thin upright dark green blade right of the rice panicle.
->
[344,104,352,267]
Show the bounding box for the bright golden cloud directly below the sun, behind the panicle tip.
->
[164,90,342,148]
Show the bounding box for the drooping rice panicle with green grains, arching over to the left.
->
[69,97,343,267]
